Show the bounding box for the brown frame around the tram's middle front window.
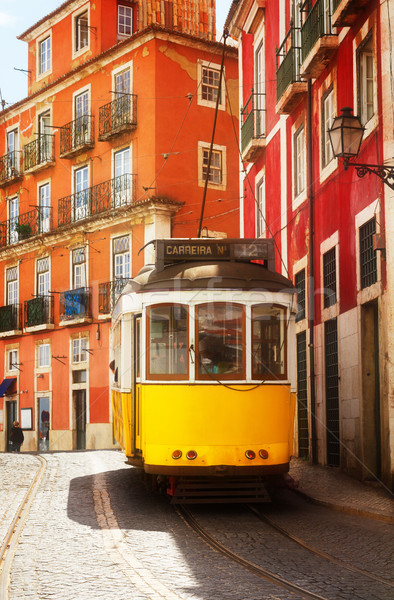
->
[195,302,246,382]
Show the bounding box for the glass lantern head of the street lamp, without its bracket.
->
[328,108,365,158]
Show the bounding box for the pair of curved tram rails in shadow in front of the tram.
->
[175,505,394,600]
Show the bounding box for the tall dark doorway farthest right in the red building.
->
[361,302,382,479]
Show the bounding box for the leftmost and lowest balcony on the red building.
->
[241,89,266,162]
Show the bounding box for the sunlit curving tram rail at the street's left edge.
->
[0,455,47,600]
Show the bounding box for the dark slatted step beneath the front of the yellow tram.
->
[171,477,271,504]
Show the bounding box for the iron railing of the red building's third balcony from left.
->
[301,0,334,61]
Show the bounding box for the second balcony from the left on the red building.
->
[276,27,308,114]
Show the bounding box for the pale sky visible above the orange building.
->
[0,0,231,106]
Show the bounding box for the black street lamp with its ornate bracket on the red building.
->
[328,107,394,190]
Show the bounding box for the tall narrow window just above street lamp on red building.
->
[357,32,375,125]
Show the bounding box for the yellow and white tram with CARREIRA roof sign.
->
[111,239,296,496]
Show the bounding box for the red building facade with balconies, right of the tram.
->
[226,0,394,487]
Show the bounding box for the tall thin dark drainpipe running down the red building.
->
[307,79,317,464]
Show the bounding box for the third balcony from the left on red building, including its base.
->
[301,0,338,79]
